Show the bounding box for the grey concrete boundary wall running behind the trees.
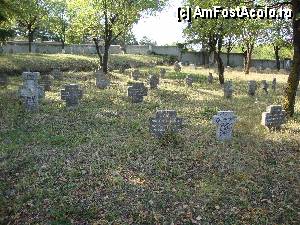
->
[0,41,289,69]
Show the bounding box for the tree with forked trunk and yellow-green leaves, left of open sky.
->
[70,0,166,73]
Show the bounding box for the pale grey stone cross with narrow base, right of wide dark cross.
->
[212,111,237,141]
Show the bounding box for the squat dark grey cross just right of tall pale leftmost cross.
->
[61,84,83,107]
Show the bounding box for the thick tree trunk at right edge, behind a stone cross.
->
[283,0,300,116]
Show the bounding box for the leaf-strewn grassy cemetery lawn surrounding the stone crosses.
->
[0,64,300,225]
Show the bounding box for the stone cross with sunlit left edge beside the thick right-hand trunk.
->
[261,105,287,130]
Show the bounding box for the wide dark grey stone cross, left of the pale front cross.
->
[149,110,183,138]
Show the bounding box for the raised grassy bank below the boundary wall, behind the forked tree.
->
[0,54,166,75]
